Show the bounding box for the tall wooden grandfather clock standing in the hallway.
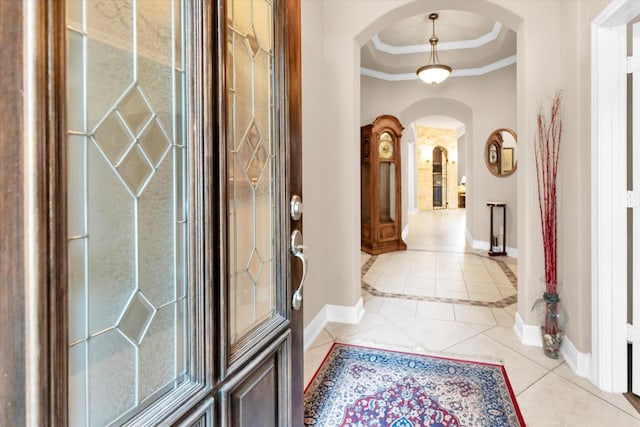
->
[360,114,407,255]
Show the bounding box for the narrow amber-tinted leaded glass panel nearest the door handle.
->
[226,0,285,346]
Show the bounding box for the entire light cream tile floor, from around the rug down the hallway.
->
[305,210,640,427]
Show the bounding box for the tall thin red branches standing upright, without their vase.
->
[534,90,562,295]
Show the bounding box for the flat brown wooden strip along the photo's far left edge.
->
[0,2,26,425]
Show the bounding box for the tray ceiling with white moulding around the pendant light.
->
[360,10,516,81]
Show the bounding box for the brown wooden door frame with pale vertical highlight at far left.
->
[0,1,66,425]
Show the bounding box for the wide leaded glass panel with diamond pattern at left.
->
[66,0,193,426]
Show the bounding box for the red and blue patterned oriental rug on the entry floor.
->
[304,343,525,427]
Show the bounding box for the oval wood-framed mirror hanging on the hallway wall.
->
[484,128,518,177]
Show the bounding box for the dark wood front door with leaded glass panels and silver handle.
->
[60,0,306,426]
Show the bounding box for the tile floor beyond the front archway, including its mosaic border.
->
[362,209,517,306]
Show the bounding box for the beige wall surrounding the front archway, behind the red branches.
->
[302,0,608,352]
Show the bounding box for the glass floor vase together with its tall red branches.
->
[534,91,567,359]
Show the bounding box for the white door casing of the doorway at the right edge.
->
[592,1,640,392]
